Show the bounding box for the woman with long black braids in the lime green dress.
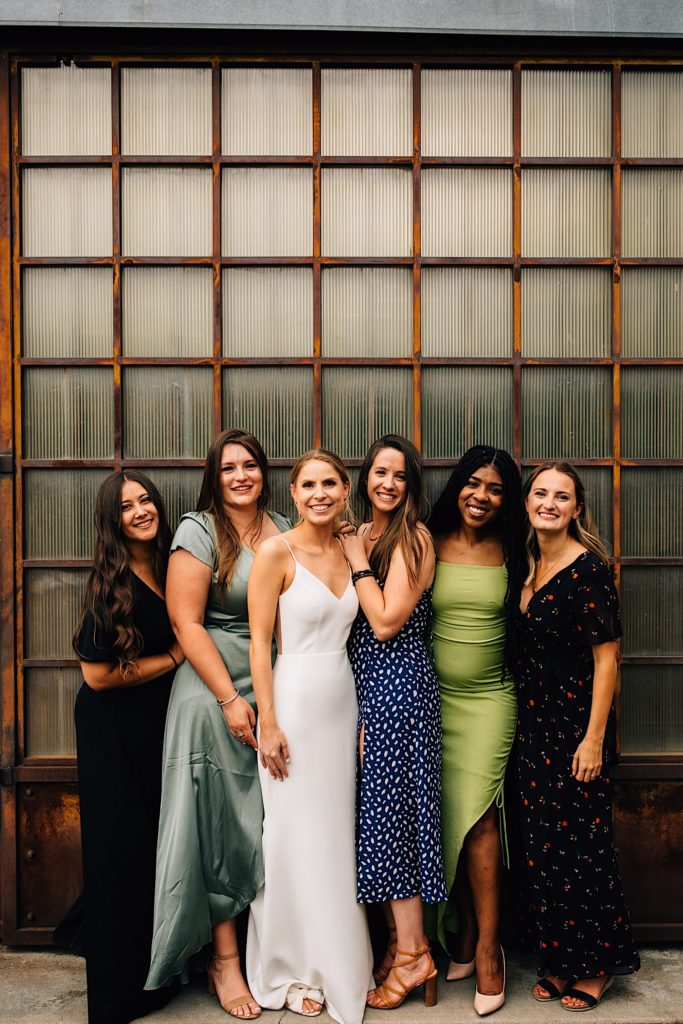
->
[428,444,525,1016]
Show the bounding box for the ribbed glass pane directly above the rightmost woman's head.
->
[522,367,612,459]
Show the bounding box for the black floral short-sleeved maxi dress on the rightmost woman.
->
[516,552,640,979]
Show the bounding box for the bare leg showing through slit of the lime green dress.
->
[463,804,503,995]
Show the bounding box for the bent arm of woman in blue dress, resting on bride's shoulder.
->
[340,528,435,640]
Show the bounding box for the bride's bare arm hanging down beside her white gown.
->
[249,537,292,780]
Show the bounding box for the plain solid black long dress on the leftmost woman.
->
[75,575,174,1024]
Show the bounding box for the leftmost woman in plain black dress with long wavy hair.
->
[74,469,182,1024]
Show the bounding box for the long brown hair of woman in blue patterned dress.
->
[358,434,426,587]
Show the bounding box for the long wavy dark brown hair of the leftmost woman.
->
[73,469,171,678]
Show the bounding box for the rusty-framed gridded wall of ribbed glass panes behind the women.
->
[13,58,683,762]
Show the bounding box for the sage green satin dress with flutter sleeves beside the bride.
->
[147,512,291,988]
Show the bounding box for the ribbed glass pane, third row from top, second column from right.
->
[521,267,611,358]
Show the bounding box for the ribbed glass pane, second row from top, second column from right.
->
[522,167,611,258]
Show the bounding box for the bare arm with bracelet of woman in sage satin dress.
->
[166,548,257,750]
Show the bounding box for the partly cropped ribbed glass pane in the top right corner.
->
[622,68,683,158]
